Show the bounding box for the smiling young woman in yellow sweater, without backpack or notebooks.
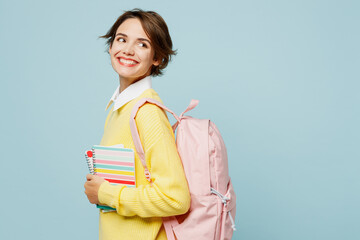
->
[85,9,190,240]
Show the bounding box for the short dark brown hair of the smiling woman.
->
[99,8,176,76]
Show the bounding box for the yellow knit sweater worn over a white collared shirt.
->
[98,89,190,240]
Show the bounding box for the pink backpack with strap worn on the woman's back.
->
[130,98,236,240]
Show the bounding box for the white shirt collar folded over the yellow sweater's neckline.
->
[105,76,151,111]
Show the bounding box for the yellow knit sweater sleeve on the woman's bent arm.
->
[99,104,190,217]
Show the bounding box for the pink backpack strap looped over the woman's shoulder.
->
[130,98,180,182]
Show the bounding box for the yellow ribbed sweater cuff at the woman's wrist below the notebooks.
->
[98,181,125,208]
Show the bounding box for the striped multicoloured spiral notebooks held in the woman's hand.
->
[85,145,136,212]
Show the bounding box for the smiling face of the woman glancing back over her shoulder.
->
[109,18,159,84]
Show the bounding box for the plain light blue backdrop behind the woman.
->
[0,0,360,240]
